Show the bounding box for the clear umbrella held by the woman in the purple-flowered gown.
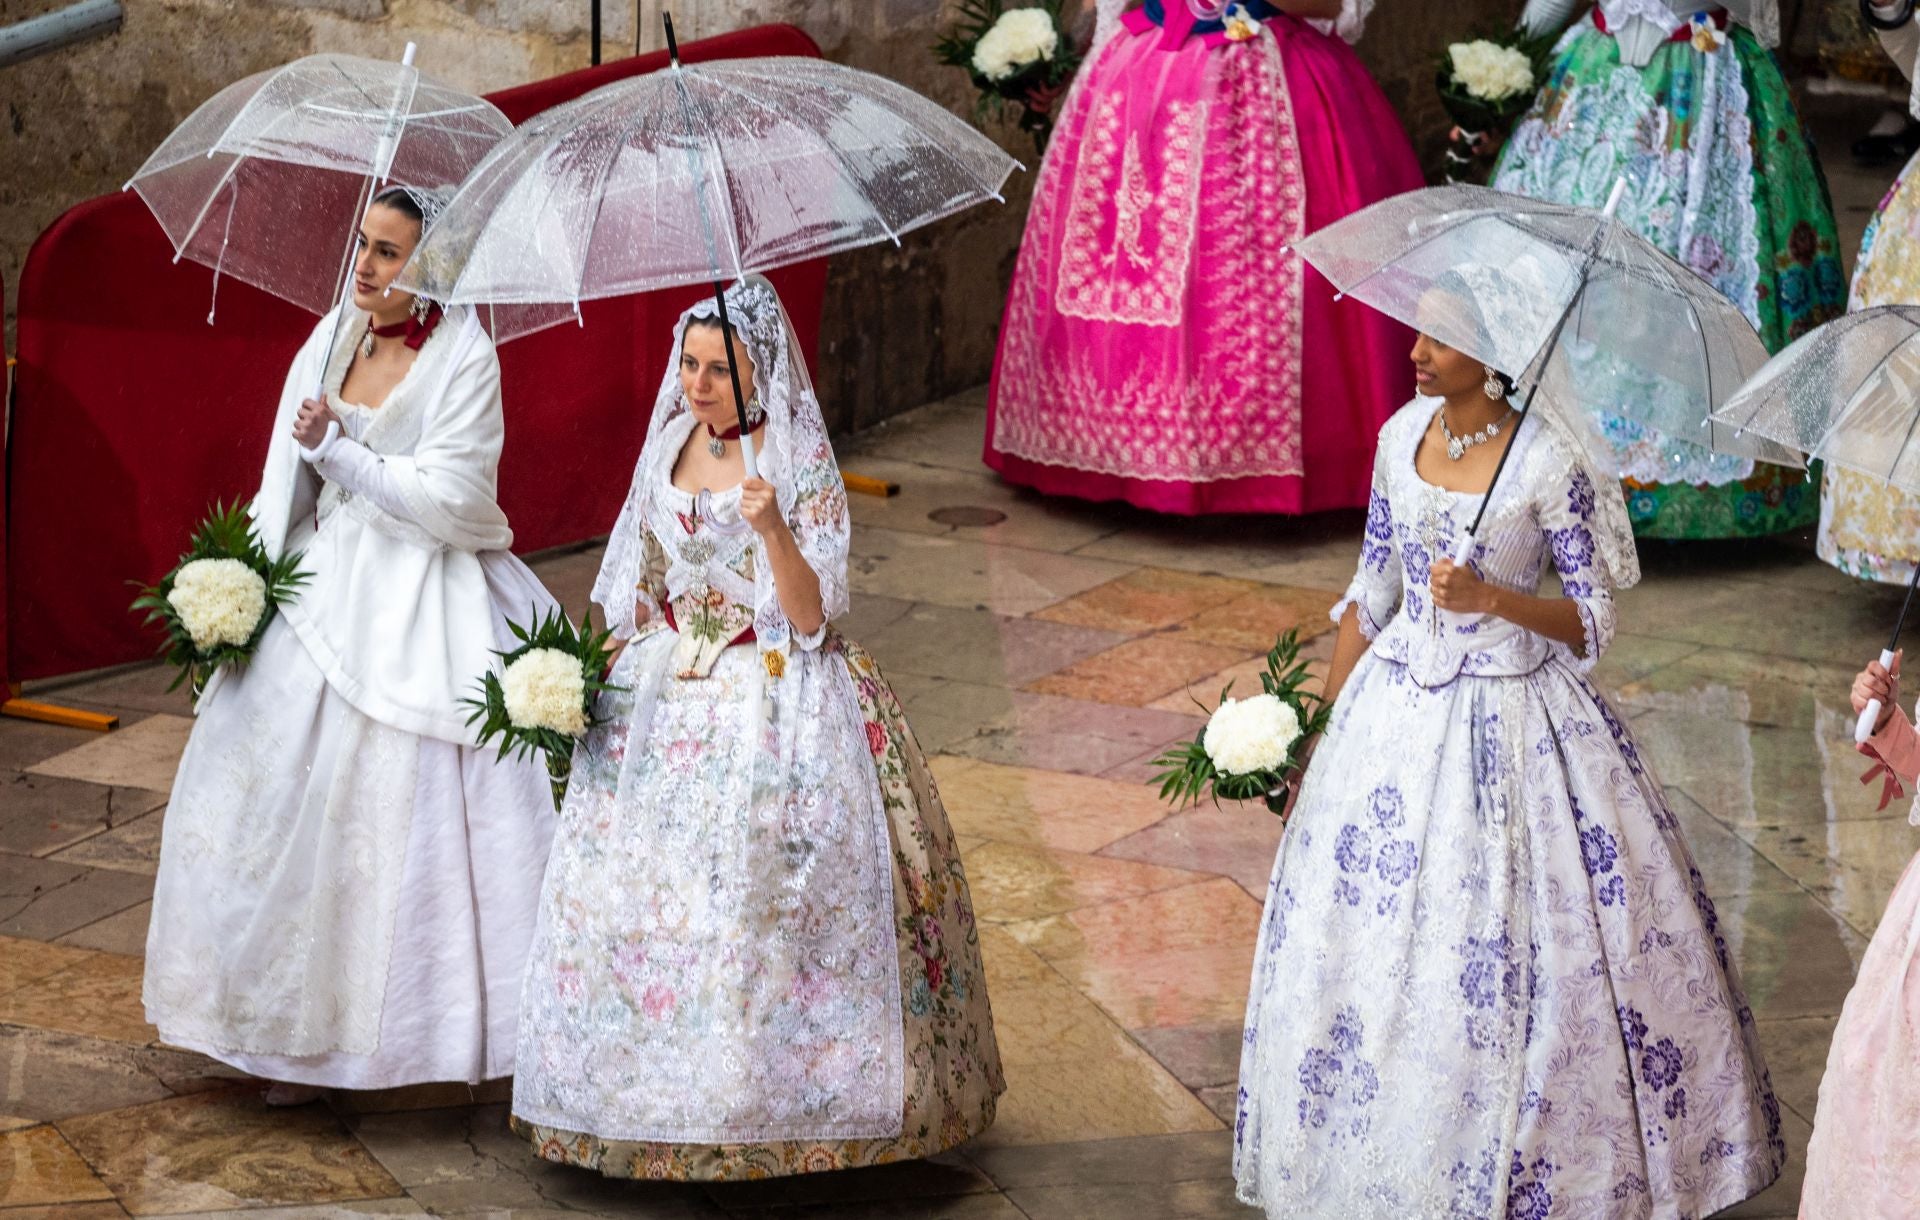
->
[1296,179,1801,555]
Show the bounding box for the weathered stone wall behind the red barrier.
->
[0,0,1521,428]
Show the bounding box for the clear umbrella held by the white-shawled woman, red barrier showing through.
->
[127,42,513,382]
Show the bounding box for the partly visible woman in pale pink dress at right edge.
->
[1801,657,1920,1220]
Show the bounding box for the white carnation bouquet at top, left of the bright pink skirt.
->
[933,0,1081,152]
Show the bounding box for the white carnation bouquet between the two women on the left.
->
[461,611,618,811]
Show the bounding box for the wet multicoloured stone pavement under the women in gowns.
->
[0,394,1920,1220]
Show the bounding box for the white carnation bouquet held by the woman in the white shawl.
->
[132,503,309,703]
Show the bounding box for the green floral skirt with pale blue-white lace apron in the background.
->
[1494,19,1845,538]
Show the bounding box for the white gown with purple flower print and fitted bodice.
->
[1235,400,1786,1220]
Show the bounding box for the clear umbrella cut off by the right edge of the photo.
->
[1715,305,1920,742]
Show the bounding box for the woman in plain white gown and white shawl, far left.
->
[144,188,553,1105]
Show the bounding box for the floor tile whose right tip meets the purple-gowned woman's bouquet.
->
[950,692,1206,774]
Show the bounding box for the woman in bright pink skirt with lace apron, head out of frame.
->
[987,0,1421,515]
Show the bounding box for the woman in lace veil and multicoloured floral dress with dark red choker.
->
[513,279,1004,1180]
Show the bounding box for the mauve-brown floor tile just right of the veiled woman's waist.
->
[860,603,1125,686]
